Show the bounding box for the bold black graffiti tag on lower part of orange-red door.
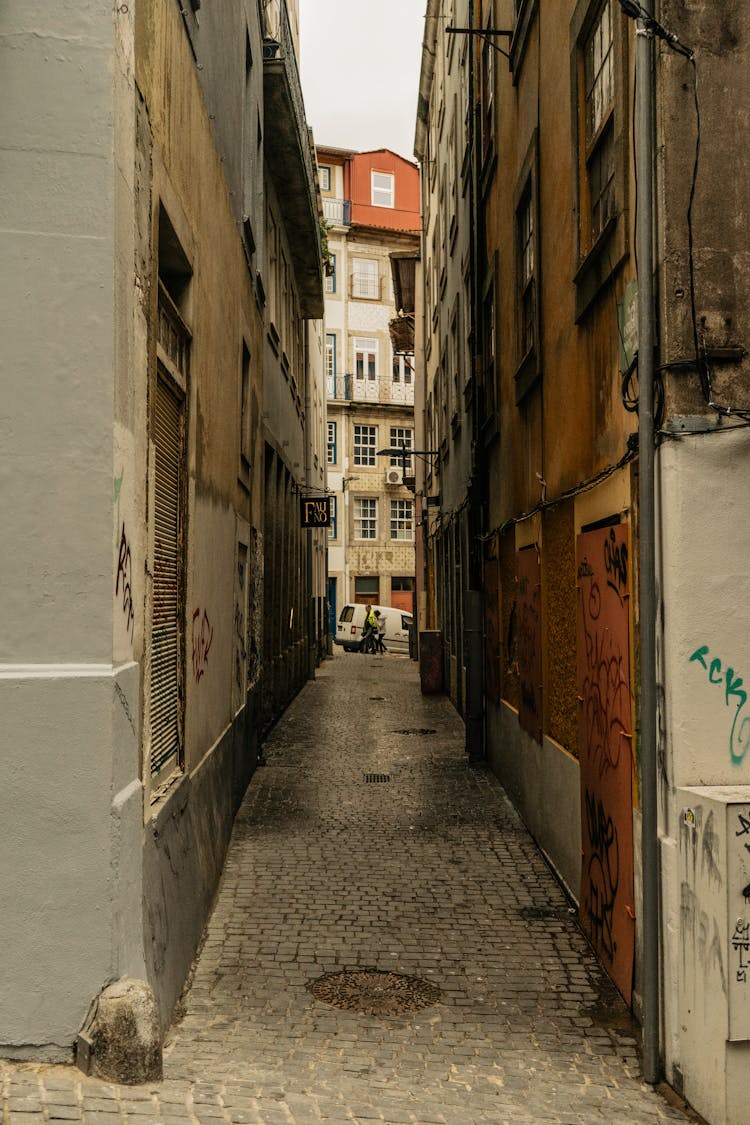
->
[585,790,620,961]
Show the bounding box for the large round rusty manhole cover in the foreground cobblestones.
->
[307,969,440,1016]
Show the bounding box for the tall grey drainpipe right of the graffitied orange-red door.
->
[635,0,660,1085]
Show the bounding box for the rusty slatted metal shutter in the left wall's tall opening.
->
[150,377,182,774]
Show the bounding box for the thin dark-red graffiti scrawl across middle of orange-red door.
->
[578,576,630,777]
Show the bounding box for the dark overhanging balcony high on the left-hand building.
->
[263,0,323,320]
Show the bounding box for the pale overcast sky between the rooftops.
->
[299,0,427,160]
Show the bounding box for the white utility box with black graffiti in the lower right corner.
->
[676,785,750,1125]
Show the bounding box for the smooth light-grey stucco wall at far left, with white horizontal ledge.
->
[0,0,136,1059]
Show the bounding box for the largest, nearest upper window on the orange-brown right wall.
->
[570,0,629,320]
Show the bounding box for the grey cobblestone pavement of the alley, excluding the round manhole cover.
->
[0,654,694,1125]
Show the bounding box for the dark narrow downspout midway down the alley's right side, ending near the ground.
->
[463,0,486,762]
